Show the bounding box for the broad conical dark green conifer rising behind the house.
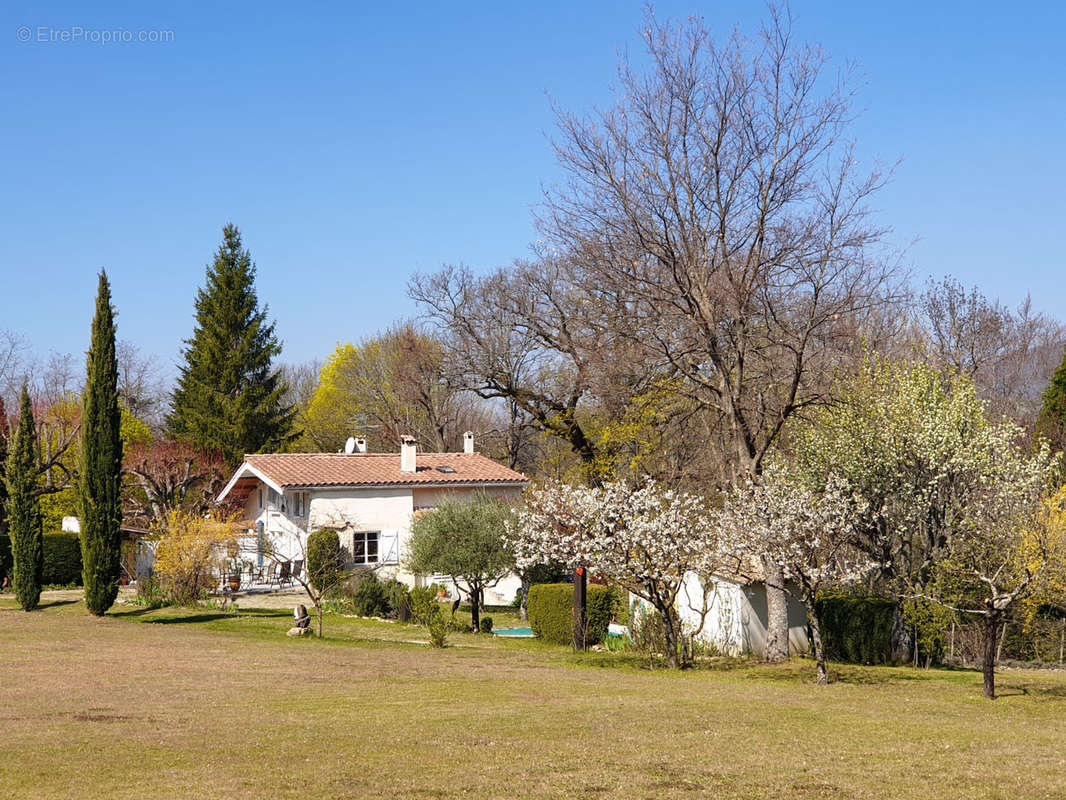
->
[167,224,294,466]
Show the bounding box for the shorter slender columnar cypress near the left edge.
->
[5,383,45,611]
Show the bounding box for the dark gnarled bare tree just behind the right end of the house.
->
[408,264,657,483]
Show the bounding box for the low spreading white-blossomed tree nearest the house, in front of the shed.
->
[507,481,721,667]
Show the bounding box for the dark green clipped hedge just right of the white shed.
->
[817,596,895,663]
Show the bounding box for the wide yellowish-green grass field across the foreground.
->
[0,599,1066,798]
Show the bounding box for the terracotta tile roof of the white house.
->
[244,452,528,486]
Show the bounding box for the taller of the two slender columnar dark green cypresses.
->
[78,272,123,615]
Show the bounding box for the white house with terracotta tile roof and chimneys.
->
[217,433,529,603]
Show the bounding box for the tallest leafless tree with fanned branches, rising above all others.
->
[539,10,894,486]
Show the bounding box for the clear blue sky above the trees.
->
[0,0,1066,375]
